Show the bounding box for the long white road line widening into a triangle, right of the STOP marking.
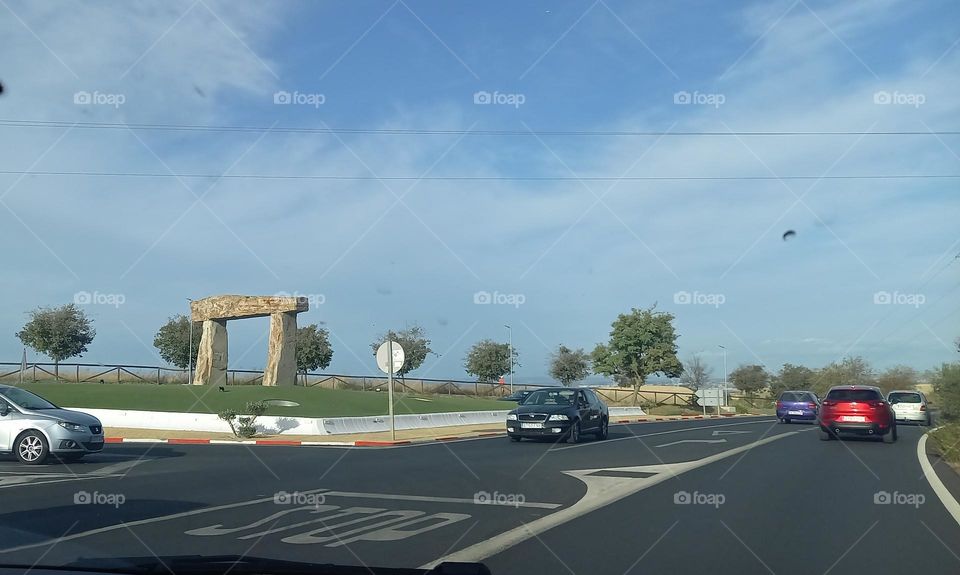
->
[420,431,800,569]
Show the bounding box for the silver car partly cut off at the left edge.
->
[0,385,103,465]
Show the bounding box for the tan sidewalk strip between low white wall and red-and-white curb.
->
[104,414,759,447]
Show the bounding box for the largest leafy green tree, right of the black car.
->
[591,305,683,392]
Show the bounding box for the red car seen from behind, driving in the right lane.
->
[819,385,897,443]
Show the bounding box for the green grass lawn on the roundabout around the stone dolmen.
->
[15,383,516,417]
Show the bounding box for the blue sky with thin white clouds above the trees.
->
[0,0,960,388]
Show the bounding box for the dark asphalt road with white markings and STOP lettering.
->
[0,418,960,575]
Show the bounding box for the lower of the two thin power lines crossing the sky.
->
[0,170,960,182]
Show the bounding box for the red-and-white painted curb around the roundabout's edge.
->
[103,413,766,447]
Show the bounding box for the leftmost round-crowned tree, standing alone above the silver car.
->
[17,303,97,378]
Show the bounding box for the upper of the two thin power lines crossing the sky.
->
[0,118,960,137]
